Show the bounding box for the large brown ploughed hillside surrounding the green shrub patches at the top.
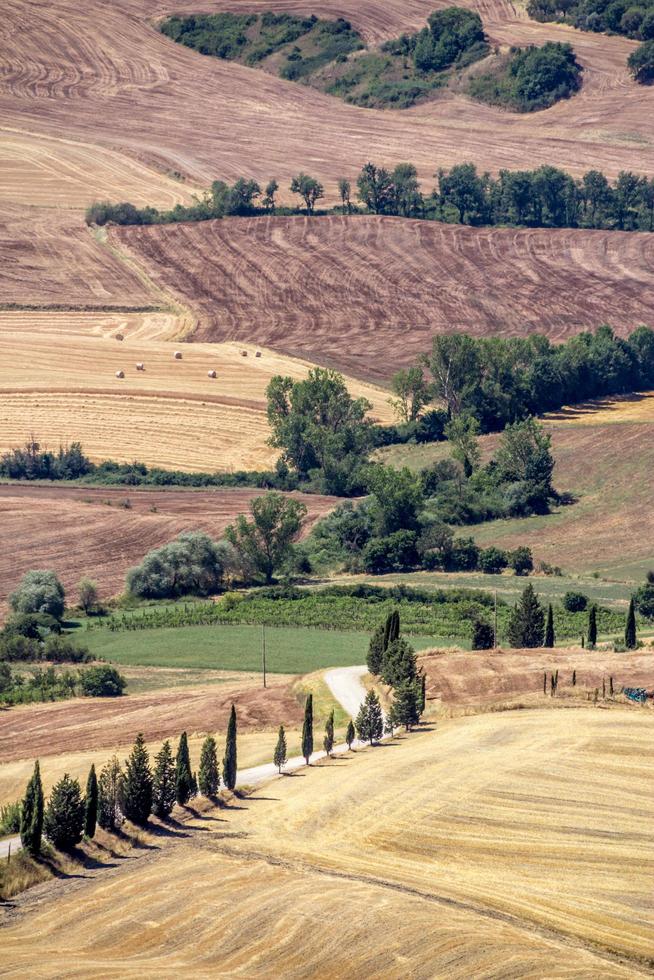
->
[0,0,654,206]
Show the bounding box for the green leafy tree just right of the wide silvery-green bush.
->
[225,491,307,584]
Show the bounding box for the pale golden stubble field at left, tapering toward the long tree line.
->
[0,129,199,208]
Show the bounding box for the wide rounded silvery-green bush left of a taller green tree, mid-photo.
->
[127,531,231,599]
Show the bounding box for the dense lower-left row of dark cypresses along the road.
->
[20,705,237,857]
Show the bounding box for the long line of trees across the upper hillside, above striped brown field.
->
[86,162,654,231]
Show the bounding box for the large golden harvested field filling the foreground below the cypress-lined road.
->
[2,708,654,980]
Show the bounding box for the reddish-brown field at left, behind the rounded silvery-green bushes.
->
[0,484,337,604]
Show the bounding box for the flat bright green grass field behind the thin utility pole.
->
[79,625,446,674]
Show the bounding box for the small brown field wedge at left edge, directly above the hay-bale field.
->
[0,205,161,309]
